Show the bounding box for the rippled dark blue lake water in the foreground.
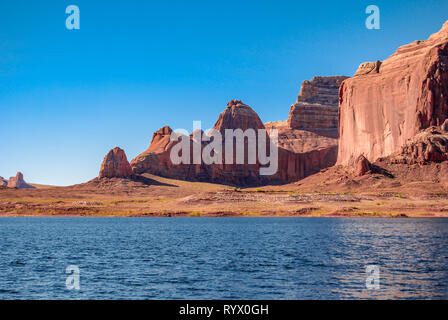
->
[0,218,448,299]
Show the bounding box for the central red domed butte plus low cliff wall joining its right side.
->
[131,100,337,186]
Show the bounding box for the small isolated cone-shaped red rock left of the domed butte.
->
[98,147,132,178]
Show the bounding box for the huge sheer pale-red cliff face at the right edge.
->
[337,22,448,165]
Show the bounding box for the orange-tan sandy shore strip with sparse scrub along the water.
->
[0,170,448,218]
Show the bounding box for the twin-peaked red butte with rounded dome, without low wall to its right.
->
[131,100,281,186]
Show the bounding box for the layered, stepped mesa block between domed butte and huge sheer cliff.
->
[288,76,347,131]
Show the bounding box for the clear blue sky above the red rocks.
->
[0,0,448,185]
